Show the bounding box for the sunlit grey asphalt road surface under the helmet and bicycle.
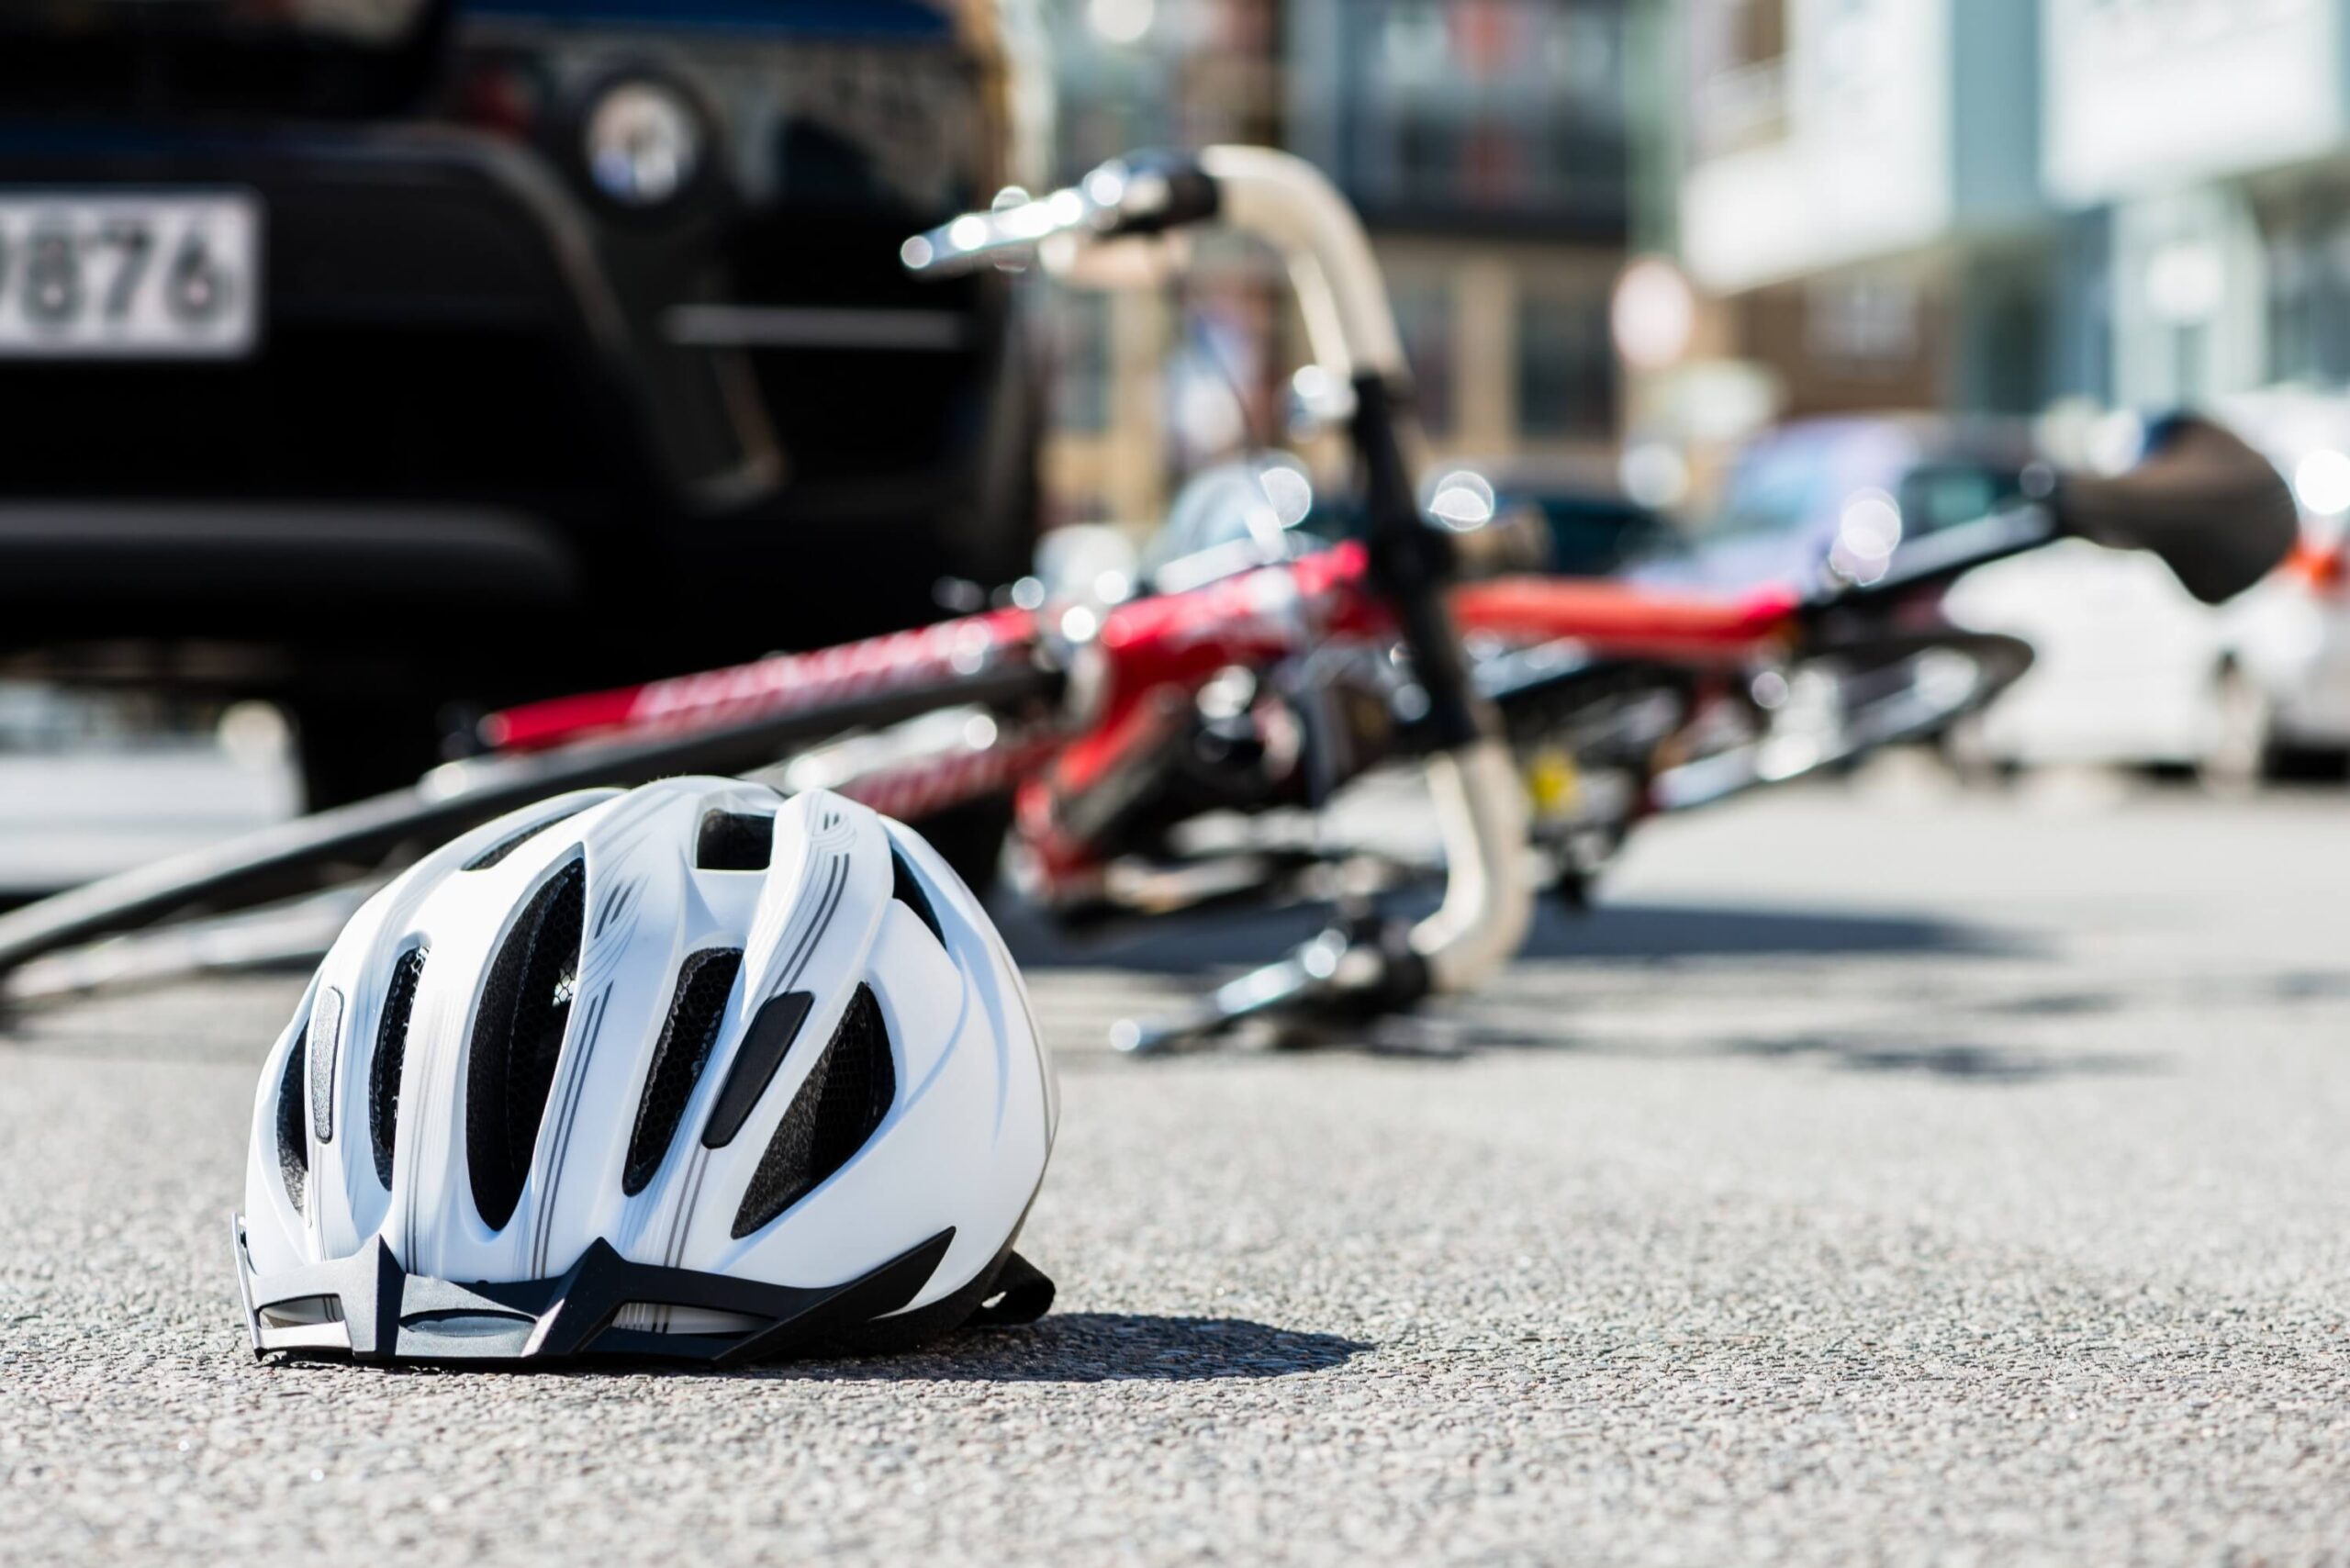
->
[0,790,2350,1568]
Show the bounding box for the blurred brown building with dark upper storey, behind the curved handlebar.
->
[1050,0,1627,517]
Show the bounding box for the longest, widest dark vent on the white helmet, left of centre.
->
[465,860,588,1229]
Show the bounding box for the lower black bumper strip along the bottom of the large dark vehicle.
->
[0,498,991,700]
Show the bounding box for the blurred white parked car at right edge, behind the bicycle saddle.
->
[1946,399,2350,783]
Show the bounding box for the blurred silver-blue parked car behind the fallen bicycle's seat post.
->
[1633,414,2032,590]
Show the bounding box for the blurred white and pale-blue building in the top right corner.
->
[2042,0,2350,407]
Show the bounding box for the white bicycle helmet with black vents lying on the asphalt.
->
[238,778,1060,1363]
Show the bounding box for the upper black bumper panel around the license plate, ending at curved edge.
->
[0,125,670,515]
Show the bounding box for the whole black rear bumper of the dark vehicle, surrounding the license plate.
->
[0,118,1032,699]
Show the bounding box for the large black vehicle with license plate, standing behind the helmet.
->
[0,0,1048,804]
